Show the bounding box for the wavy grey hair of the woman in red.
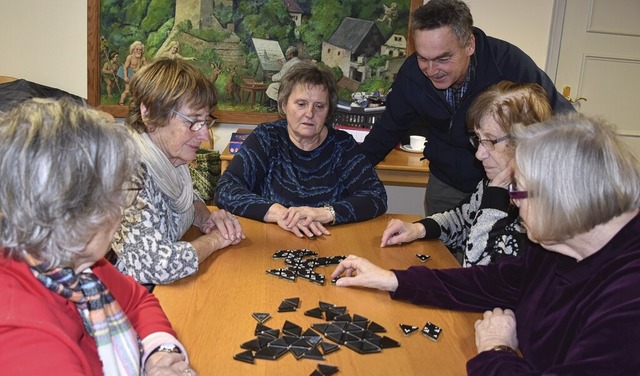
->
[0,98,138,269]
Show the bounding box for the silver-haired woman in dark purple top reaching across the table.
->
[332,114,640,376]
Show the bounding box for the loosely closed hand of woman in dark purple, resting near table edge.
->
[475,308,518,353]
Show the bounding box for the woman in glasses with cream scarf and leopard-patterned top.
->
[113,58,244,284]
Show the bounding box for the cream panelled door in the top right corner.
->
[550,0,640,158]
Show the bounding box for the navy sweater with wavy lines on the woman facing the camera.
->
[215,120,387,223]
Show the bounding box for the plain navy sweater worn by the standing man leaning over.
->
[361,28,574,193]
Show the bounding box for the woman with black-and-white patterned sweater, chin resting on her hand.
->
[380,81,551,266]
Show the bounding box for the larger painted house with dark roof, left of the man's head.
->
[322,17,385,82]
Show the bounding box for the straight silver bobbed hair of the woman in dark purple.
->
[513,113,640,242]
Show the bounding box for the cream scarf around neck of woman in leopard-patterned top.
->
[134,132,195,237]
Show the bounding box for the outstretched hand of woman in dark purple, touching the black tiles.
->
[331,255,398,291]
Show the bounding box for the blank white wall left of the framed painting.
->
[0,0,87,98]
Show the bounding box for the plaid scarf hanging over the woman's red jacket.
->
[24,253,143,376]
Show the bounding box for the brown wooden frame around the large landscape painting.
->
[87,0,423,124]
